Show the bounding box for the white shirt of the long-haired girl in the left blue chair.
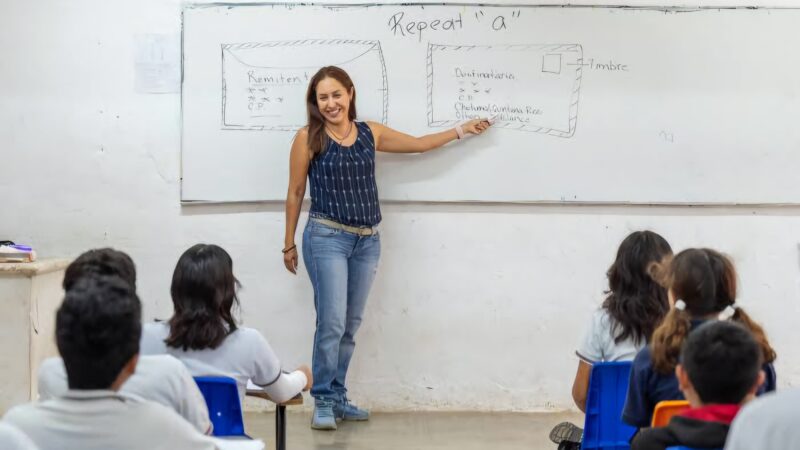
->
[139,322,290,404]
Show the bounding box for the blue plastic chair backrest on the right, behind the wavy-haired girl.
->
[581,361,636,450]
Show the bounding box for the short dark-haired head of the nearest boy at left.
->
[56,275,142,390]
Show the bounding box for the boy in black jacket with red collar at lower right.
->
[631,322,764,450]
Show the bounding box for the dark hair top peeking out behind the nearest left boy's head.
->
[62,248,136,291]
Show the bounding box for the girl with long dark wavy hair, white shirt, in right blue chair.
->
[550,231,672,449]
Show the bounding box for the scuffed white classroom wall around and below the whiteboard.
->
[0,0,800,410]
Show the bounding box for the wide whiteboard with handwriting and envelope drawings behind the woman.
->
[181,4,800,204]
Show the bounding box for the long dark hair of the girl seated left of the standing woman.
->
[164,244,239,350]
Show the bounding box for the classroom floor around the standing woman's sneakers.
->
[245,412,583,450]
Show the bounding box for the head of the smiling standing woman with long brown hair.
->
[306,66,356,156]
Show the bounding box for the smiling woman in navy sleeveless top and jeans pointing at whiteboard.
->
[283,66,489,430]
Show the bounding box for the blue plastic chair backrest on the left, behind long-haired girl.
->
[194,377,245,436]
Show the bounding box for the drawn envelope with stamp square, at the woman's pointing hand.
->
[428,44,583,137]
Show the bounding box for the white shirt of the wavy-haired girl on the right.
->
[575,308,647,364]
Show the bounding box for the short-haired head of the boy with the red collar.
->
[675,321,764,407]
